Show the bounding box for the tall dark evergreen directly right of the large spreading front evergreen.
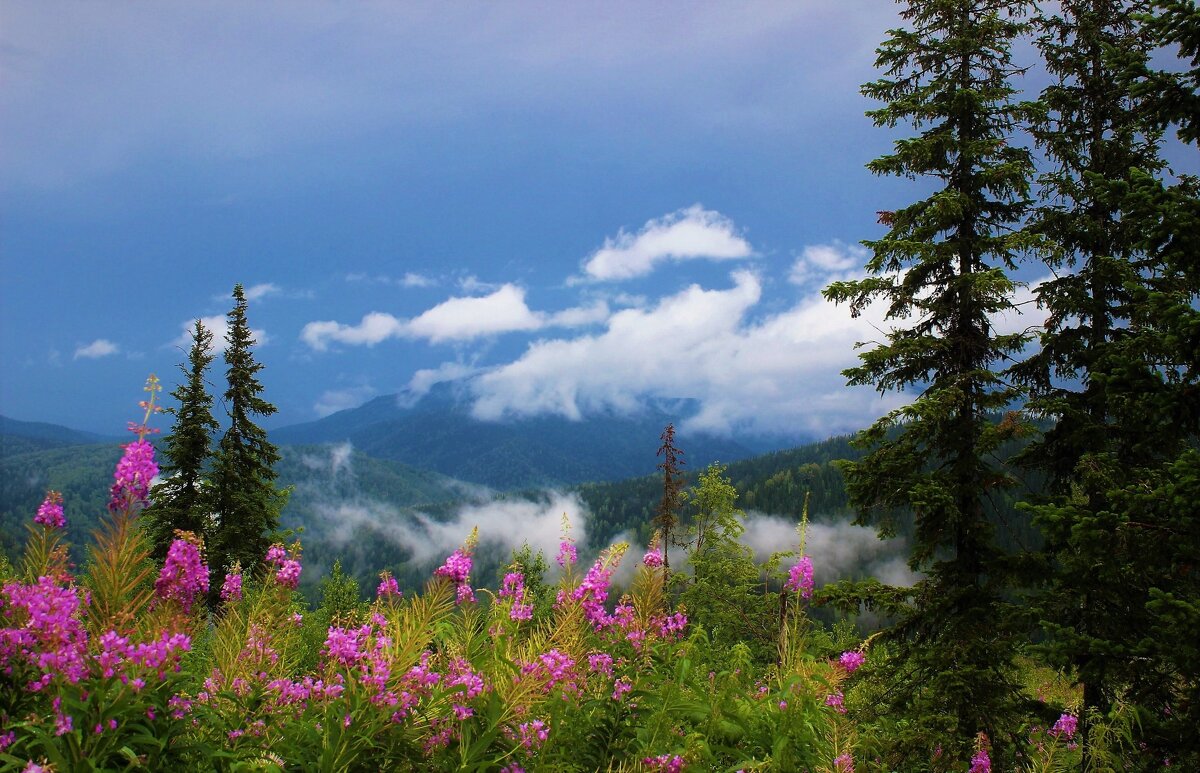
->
[1013,0,1180,755]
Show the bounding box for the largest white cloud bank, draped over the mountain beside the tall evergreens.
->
[473,271,902,435]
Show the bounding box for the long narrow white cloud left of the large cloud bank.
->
[300,283,608,350]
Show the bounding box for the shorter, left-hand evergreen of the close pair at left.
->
[142,319,221,561]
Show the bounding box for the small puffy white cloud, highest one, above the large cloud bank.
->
[575,204,754,281]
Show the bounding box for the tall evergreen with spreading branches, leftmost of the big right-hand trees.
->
[826,0,1032,768]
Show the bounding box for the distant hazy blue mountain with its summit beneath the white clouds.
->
[271,384,772,490]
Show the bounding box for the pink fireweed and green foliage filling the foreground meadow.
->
[0,382,1074,773]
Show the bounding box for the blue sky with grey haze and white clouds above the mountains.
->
[0,0,1190,437]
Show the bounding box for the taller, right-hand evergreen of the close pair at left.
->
[209,284,287,588]
